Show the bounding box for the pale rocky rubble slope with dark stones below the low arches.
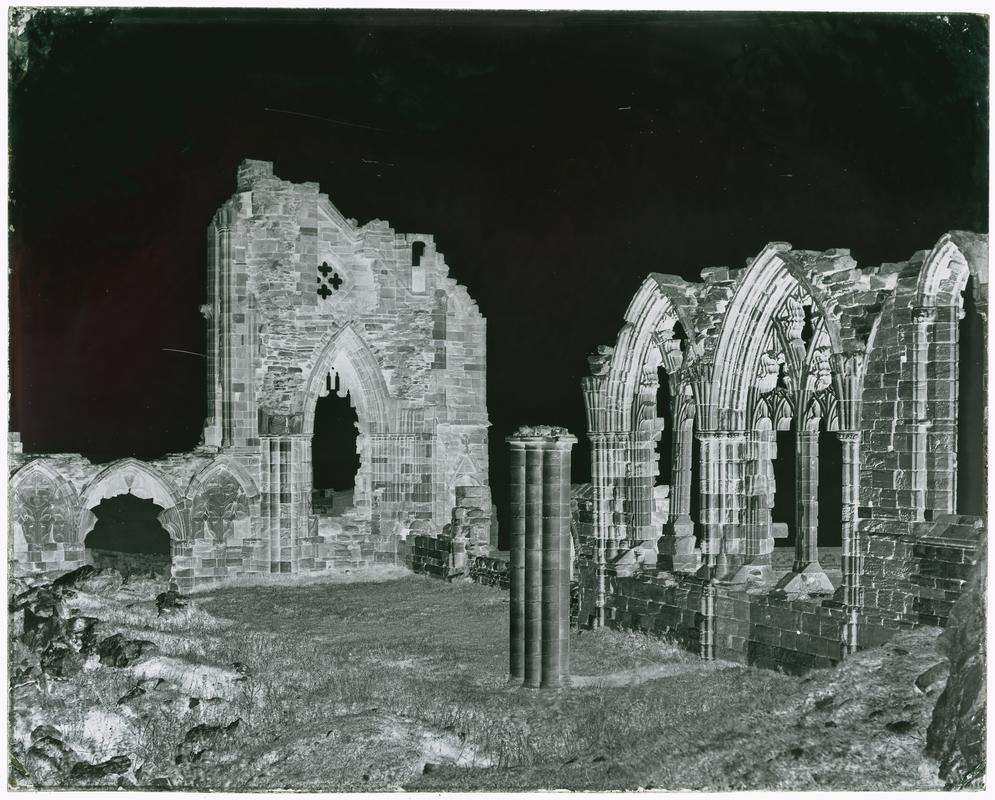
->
[9,566,244,788]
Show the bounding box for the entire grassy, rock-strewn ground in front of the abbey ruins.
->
[8,566,985,791]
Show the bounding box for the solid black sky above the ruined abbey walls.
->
[9,10,989,540]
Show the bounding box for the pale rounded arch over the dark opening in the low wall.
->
[77,458,187,542]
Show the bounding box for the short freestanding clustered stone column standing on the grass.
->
[507,426,577,688]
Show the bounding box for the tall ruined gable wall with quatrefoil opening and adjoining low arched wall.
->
[9,161,493,590]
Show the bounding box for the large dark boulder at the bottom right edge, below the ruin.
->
[926,543,988,788]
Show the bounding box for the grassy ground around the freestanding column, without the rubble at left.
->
[9,573,941,791]
